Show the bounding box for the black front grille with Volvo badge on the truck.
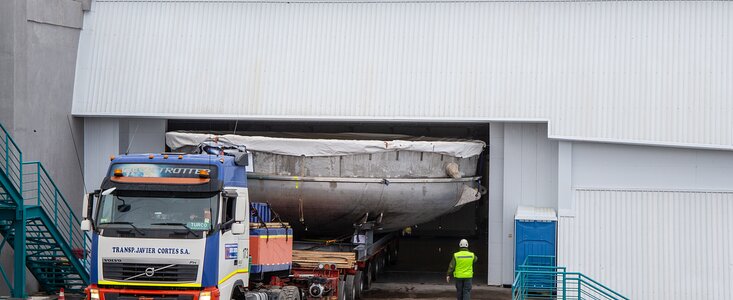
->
[102,263,198,282]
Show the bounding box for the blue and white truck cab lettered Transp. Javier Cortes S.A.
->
[82,152,250,300]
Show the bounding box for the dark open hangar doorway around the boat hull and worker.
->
[167,120,489,282]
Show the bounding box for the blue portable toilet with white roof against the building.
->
[514,206,557,274]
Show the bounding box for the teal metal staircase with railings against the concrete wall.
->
[0,124,91,298]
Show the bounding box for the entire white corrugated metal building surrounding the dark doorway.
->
[73,0,733,299]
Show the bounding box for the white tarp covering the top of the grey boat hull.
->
[165,132,486,158]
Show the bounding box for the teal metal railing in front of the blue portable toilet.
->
[512,256,628,300]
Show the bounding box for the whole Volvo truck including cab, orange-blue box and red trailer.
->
[81,150,387,300]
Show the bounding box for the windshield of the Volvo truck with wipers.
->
[97,192,219,238]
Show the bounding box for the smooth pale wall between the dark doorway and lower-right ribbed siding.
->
[488,123,558,285]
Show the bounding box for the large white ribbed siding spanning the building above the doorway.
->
[73,1,733,148]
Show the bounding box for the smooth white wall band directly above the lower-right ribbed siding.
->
[572,142,733,192]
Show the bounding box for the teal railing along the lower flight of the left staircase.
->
[23,161,92,273]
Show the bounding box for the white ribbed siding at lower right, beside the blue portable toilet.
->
[558,190,733,299]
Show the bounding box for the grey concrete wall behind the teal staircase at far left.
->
[0,0,89,295]
